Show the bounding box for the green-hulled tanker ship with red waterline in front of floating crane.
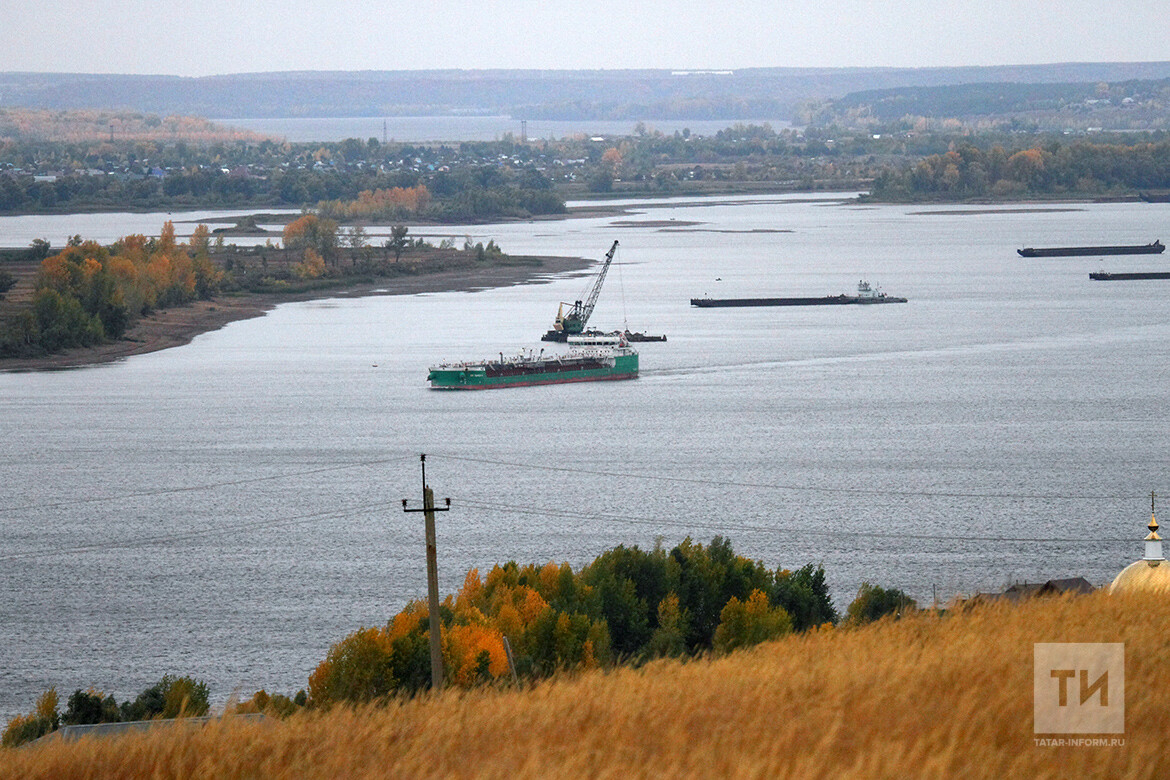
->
[427,343,638,389]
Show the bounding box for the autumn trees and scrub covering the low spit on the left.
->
[0,215,517,359]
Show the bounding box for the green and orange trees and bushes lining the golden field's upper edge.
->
[0,537,917,746]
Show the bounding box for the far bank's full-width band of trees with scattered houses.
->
[11,123,1170,214]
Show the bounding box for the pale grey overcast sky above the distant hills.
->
[0,0,1170,76]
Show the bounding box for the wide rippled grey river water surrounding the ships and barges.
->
[0,191,1170,717]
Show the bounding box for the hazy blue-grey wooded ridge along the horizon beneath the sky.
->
[0,62,1170,120]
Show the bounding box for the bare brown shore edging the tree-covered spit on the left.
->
[0,256,596,373]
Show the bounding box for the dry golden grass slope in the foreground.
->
[0,593,1170,779]
